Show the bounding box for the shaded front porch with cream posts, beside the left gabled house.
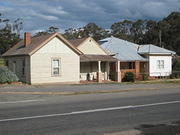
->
[80,55,121,82]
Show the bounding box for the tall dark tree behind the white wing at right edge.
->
[143,12,180,54]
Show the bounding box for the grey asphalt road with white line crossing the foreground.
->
[0,88,180,135]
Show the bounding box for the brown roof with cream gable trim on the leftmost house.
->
[2,33,82,56]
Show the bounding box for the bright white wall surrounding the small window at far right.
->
[149,56,172,76]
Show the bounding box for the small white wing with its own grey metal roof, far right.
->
[138,44,176,77]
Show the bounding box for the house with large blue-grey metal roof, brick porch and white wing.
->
[99,37,175,78]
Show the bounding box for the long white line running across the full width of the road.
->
[0,101,180,122]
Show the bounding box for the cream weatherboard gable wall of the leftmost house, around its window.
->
[31,37,80,84]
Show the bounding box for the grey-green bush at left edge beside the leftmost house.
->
[0,67,19,83]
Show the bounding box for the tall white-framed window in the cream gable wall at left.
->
[52,59,60,76]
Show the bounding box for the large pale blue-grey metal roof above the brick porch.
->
[99,37,147,61]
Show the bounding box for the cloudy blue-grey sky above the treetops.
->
[0,0,180,33]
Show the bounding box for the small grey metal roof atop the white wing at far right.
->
[138,44,176,54]
